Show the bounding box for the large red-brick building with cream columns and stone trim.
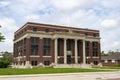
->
[13,22,101,68]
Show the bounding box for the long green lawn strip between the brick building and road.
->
[0,68,113,75]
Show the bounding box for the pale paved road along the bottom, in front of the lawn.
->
[0,71,120,80]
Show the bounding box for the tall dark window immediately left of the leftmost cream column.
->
[43,38,50,56]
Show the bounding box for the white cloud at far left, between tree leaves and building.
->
[0,17,18,52]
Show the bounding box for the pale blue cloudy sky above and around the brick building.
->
[0,0,120,52]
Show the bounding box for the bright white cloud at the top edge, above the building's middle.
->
[51,0,98,10]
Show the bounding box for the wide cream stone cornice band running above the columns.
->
[14,30,100,43]
